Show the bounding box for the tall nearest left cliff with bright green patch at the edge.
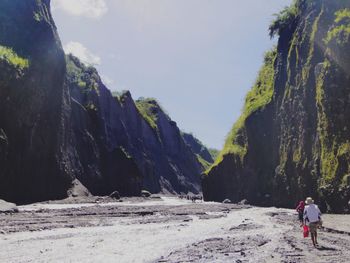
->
[0,0,71,202]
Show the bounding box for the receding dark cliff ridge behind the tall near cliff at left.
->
[67,55,202,195]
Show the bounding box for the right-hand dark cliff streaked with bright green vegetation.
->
[203,0,350,212]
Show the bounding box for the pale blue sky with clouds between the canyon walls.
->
[51,0,292,149]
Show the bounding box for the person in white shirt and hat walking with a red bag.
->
[304,197,321,247]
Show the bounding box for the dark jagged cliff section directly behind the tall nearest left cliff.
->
[66,56,142,196]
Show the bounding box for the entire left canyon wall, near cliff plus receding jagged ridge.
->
[0,0,203,203]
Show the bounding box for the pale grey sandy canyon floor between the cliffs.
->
[0,197,350,263]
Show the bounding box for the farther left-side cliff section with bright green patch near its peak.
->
[131,97,203,193]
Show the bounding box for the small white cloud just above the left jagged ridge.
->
[63,41,101,65]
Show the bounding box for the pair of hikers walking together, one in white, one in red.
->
[296,197,322,247]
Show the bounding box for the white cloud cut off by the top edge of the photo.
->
[52,0,108,19]
